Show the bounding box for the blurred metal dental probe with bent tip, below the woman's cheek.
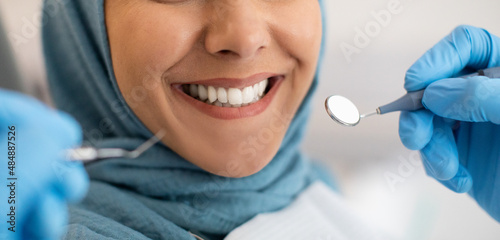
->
[66,129,166,163]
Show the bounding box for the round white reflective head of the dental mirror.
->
[325,95,360,126]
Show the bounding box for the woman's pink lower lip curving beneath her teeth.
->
[172,76,283,120]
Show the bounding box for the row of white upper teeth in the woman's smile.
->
[186,79,269,107]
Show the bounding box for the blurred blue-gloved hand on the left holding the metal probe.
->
[0,89,89,240]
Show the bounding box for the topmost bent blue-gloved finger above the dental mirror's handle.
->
[405,25,500,91]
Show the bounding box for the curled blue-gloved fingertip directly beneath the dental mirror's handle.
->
[399,109,434,150]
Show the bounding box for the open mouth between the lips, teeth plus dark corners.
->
[181,76,279,108]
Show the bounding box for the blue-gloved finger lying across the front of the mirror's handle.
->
[422,76,500,124]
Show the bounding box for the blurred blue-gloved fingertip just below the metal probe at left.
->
[52,161,89,202]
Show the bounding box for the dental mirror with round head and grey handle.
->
[325,67,500,127]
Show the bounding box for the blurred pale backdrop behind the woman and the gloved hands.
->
[0,0,500,240]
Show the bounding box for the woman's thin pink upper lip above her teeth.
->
[173,72,280,88]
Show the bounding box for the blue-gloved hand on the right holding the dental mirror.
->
[399,26,500,221]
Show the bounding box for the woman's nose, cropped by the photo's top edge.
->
[205,0,270,59]
